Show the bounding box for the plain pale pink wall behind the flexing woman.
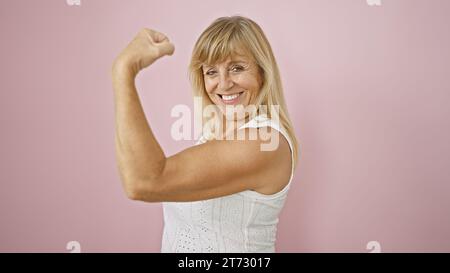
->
[0,0,450,252]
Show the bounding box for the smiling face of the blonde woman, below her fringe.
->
[202,51,262,119]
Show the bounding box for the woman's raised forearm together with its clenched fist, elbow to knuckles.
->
[111,29,174,199]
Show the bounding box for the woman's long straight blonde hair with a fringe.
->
[189,16,298,166]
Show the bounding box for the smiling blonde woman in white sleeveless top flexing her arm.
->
[112,16,297,252]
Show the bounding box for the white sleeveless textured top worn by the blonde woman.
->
[161,115,294,253]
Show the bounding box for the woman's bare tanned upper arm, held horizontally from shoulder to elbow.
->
[134,128,290,202]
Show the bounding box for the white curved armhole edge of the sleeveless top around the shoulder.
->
[238,118,294,199]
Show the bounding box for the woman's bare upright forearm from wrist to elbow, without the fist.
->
[112,65,166,195]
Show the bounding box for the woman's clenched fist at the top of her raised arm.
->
[113,28,175,77]
